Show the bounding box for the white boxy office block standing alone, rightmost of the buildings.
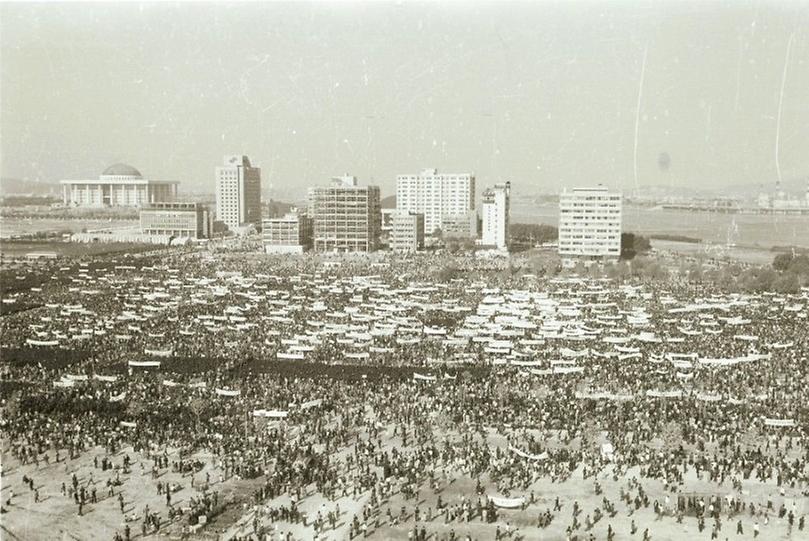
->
[559,185,621,260]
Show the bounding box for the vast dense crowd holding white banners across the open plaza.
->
[0,254,809,539]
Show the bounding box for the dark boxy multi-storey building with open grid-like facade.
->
[309,175,382,252]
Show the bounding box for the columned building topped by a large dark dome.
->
[61,163,179,207]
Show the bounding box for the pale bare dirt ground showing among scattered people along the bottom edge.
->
[0,426,809,541]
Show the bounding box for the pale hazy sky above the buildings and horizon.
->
[0,0,809,198]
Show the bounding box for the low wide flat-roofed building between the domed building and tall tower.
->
[140,202,212,239]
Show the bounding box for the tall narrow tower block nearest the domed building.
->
[216,156,261,229]
